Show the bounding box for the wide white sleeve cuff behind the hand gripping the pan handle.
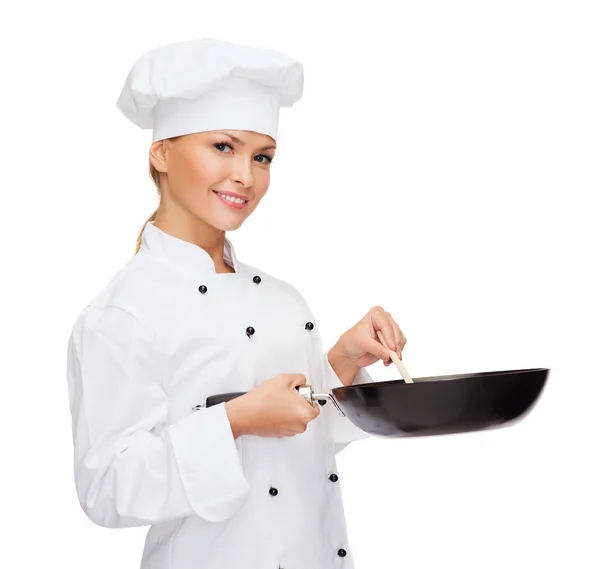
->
[168,403,250,522]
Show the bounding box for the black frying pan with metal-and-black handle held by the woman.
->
[196,368,550,437]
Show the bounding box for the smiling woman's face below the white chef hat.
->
[150,130,275,231]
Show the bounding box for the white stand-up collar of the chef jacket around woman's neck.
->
[140,221,241,276]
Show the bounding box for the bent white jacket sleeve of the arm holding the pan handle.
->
[67,306,249,528]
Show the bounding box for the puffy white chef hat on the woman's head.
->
[117,38,304,142]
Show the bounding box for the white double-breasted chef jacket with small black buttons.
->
[67,222,372,569]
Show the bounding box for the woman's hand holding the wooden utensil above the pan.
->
[335,306,406,368]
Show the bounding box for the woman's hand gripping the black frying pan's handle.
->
[225,373,320,438]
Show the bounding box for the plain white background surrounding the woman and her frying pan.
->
[0,0,600,569]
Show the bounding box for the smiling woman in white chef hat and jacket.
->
[67,39,406,569]
